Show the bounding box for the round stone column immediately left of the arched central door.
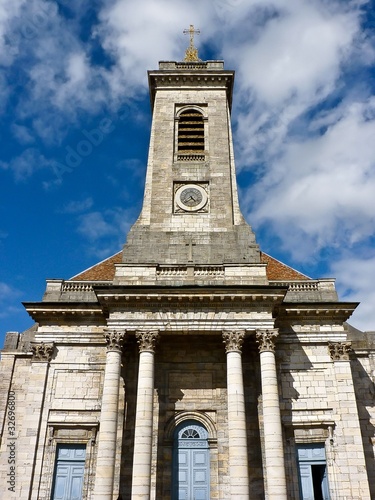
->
[132,330,159,500]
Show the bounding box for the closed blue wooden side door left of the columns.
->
[52,445,86,500]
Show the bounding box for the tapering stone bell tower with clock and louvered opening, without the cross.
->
[116,41,260,283]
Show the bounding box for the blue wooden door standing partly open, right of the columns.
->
[297,444,329,500]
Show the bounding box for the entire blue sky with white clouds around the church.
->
[0,0,375,344]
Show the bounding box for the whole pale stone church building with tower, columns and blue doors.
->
[0,56,375,500]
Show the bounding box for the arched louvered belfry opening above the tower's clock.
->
[178,109,204,154]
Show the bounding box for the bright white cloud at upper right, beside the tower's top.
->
[228,0,359,106]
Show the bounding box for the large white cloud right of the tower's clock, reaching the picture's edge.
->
[245,98,375,259]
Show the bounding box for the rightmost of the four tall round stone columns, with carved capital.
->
[256,330,287,500]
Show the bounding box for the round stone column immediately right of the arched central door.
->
[223,330,249,500]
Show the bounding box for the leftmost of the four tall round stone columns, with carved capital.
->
[94,330,125,500]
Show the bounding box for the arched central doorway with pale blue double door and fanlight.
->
[172,420,210,500]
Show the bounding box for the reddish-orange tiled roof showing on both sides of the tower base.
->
[71,252,310,281]
